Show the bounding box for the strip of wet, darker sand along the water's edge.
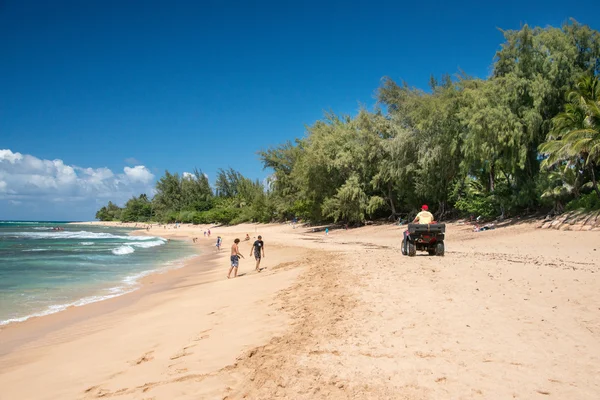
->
[0,222,221,357]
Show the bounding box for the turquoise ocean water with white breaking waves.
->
[0,221,197,325]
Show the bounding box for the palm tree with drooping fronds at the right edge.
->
[539,75,600,198]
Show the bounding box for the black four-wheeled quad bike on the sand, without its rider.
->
[402,224,446,257]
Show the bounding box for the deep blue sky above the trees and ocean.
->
[0,0,600,219]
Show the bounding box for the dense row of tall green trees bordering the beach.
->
[96,21,600,223]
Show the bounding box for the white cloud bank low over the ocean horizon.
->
[0,149,154,218]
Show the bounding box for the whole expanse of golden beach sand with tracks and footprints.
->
[0,223,600,400]
